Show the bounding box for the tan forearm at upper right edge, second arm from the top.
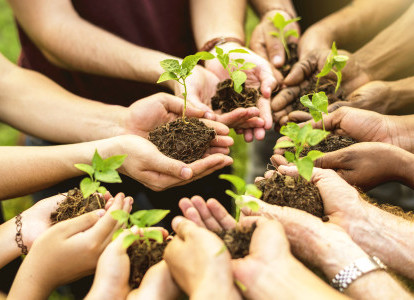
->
[353,5,414,80]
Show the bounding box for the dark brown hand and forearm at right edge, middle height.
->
[271,143,414,191]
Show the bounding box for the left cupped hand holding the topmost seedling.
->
[250,9,300,68]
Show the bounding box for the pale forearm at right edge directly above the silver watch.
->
[347,203,414,279]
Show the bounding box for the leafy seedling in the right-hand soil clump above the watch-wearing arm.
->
[275,123,329,181]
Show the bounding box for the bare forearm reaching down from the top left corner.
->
[10,0,172,87]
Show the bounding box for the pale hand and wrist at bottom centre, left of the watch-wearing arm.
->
[180,196,346,299]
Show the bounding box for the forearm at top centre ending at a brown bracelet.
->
[190,0,246,48]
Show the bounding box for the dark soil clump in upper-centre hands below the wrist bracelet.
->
[211,79,260,113]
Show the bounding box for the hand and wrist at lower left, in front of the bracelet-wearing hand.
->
[9,194,133,299]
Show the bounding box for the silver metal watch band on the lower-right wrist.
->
[331,256,387,292]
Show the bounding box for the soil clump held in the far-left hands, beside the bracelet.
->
[50,188,105,225]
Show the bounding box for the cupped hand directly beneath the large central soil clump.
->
[106,135,233,191]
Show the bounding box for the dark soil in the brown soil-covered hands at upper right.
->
[292,74,345,112]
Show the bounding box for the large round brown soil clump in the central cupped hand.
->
[149,118,216,163]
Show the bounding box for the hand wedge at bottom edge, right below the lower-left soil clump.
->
[127,260,181,300]
